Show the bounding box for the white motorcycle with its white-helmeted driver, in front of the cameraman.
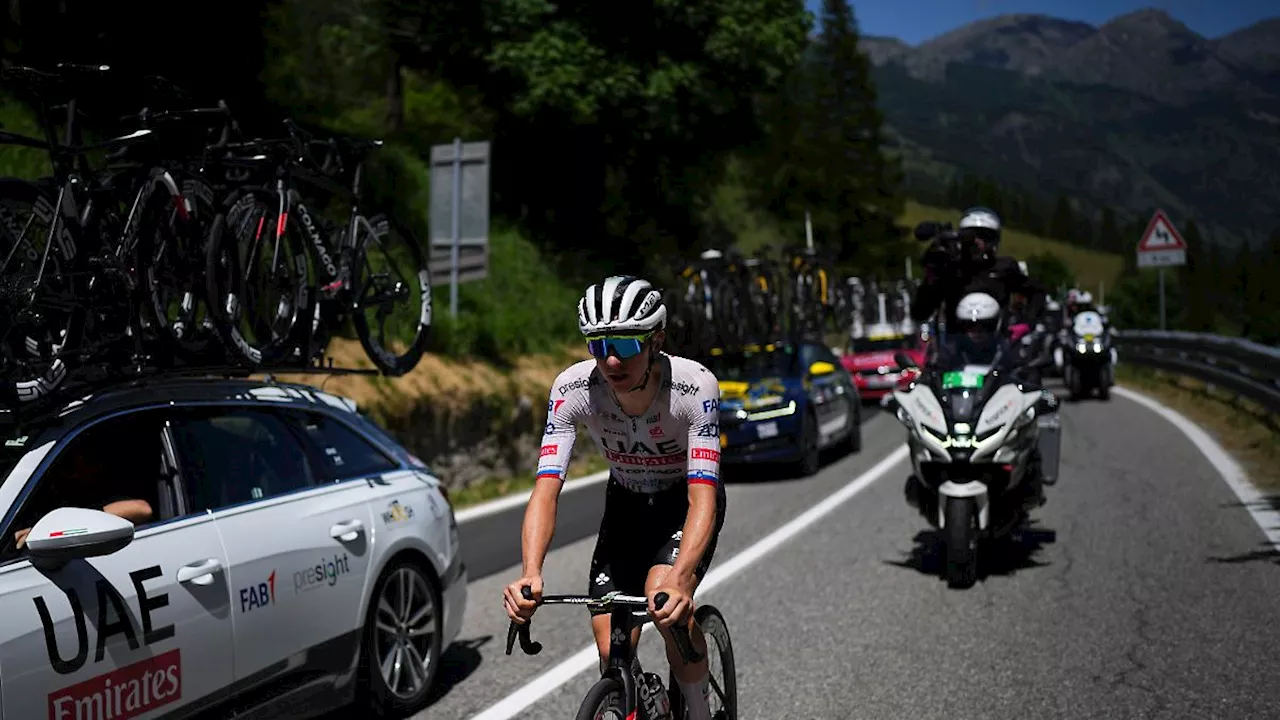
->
[881,292,1060,588]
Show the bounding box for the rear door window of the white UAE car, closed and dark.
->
[173,407,315,511]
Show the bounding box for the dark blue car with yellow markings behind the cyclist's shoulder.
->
[703,342,863,477]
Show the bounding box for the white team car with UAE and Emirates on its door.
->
[0,379,466,720]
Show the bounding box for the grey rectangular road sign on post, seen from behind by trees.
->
[429,137,490,318]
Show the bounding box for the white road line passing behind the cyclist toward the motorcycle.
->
[471,445,906,720]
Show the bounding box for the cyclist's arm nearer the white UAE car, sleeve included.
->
[521,370,589,578]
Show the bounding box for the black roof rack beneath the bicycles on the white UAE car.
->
[0,357,383,432]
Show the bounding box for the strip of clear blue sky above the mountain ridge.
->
[805,0,1280,45]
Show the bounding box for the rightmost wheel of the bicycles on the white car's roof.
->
[351,213,431,375]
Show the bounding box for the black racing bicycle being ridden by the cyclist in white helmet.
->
[507,585,737,720]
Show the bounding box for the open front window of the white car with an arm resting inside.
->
[0,411,175,561]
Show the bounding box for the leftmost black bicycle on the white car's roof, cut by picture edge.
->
[0,64,230,406]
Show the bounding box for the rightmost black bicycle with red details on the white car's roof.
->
[209,120,431,375]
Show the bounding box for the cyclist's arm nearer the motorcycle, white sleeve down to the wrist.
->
[671,369,721,587]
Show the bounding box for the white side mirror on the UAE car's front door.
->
[27,507,133,568]
